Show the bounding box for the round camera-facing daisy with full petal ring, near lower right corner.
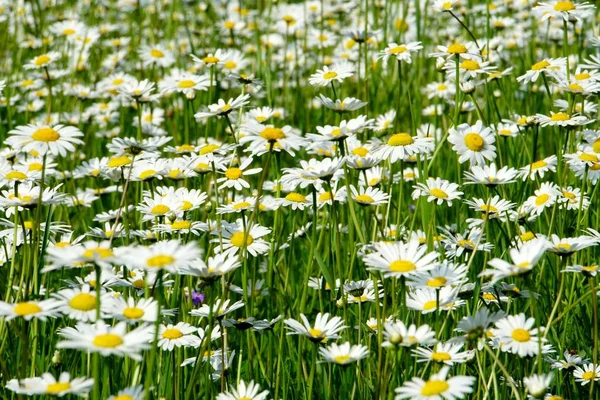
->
[493,313,546,357]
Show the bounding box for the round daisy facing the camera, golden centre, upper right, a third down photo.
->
[448,121,496,165]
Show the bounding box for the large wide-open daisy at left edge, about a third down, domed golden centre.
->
[5,125,83,157]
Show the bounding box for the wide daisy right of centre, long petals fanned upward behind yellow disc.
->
[363,240,439,278]
